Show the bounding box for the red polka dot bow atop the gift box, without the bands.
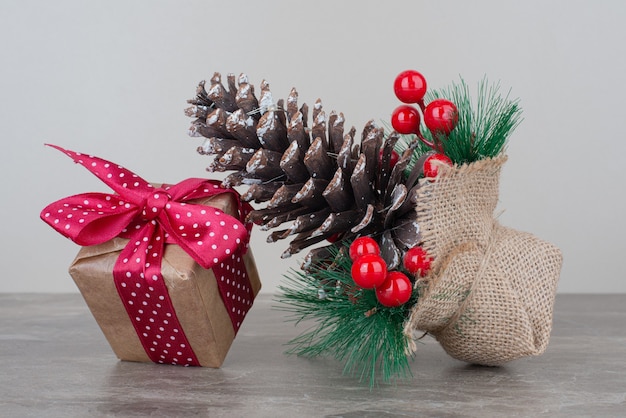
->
[41,146,249,268]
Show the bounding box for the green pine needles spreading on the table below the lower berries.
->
[278,248,417,387]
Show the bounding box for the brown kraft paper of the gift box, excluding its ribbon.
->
[70,193,261,367]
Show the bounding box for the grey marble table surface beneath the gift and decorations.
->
[0,294,626,418]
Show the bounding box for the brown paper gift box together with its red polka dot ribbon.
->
[41,145,261,367]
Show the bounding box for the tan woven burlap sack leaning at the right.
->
[407,156,562,365]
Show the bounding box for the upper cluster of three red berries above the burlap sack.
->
[391,70,459,153]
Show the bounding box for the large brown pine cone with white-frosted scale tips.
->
[185,73,421,269]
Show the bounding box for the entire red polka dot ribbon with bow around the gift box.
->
[41,145,254,365]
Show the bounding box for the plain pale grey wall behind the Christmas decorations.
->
[0,0,626,293]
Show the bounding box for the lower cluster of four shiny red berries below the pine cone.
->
[349,237,431,307]
